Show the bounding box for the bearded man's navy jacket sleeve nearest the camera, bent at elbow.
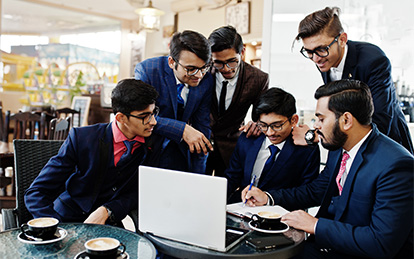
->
[315,158,413,258]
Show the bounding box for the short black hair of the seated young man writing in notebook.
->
[252,87,296,121]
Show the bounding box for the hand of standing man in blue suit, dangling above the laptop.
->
[183,124,213,155]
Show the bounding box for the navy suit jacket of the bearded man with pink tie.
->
[270,125,414,258]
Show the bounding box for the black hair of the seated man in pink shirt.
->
[111,78,158,114]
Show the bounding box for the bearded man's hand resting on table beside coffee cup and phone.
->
[280,210,318,234]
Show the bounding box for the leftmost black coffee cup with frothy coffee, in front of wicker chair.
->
[20,217,59,240]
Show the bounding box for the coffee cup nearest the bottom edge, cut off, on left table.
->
[85,237,126,258]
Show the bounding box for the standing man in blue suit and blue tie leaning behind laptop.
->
[135,30,214,173]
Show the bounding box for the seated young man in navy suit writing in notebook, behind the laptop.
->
[225,88,320,203]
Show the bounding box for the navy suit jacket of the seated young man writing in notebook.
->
[225,133,320,202]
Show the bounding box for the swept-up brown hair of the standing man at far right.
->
[296,7,344,40]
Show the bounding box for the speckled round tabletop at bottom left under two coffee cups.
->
[0,223,156,259]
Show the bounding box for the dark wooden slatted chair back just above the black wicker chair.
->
[3,111,46,142]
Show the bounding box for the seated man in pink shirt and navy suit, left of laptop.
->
[25,79,158,228]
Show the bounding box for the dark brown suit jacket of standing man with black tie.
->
[210,61,269,167]
